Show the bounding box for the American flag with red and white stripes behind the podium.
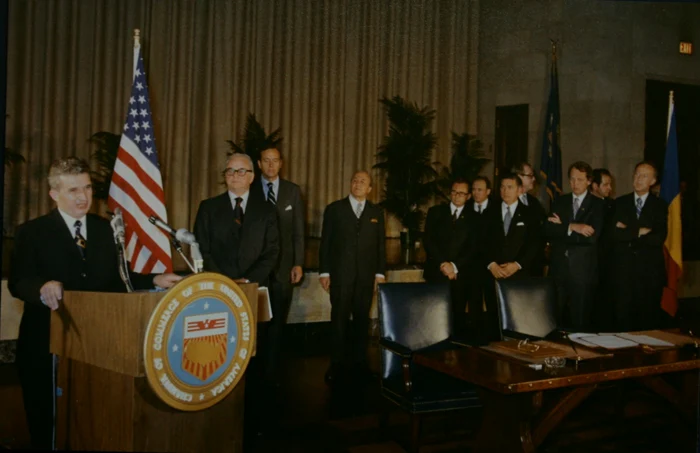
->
[107,45,173,274]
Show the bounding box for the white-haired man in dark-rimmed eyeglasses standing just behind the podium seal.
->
[194,153,279,285]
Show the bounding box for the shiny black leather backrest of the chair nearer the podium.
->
[377,282,452,378]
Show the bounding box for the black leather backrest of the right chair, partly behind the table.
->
[496,277,557,338]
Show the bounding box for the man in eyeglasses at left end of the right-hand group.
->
[423,179,482,336]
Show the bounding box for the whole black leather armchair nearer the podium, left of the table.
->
[378,283,481,450]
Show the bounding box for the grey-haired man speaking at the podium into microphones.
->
[9,157,182,450]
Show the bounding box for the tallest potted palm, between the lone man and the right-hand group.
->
[374,96,438,261]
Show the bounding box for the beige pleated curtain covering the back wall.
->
[4,0,478,240]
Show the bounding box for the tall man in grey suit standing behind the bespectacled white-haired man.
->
[256,148,304,384]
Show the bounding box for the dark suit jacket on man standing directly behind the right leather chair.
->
[484,201,540,277]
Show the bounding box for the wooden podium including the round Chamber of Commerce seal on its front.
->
[51,273,258,452]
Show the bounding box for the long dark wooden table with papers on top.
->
[414,347,700,452]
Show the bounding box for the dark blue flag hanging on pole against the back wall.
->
[540,56,562,200]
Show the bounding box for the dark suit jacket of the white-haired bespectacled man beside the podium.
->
[194,191,279,285]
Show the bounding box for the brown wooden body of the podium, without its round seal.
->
[51,284,258,452]
